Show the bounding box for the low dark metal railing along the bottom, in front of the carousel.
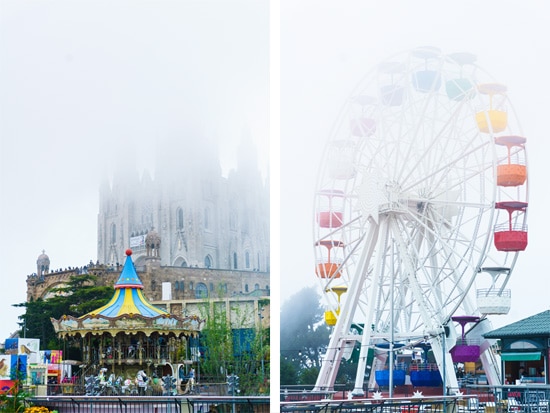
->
[28,396,269,413]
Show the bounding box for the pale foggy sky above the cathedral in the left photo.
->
[0,0,269,340]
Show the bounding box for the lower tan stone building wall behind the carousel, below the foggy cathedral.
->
[27,260,271,334]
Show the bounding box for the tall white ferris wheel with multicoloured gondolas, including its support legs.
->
[314,47,528,394]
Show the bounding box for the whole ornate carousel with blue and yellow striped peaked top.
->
[51,249,203,384]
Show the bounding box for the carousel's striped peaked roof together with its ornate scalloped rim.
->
[51,250,202,336]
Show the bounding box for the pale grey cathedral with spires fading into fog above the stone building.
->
[97,131,269,272]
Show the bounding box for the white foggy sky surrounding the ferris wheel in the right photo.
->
[280,0,550,327]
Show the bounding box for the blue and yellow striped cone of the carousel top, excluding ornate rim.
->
[85,250,168,318]
